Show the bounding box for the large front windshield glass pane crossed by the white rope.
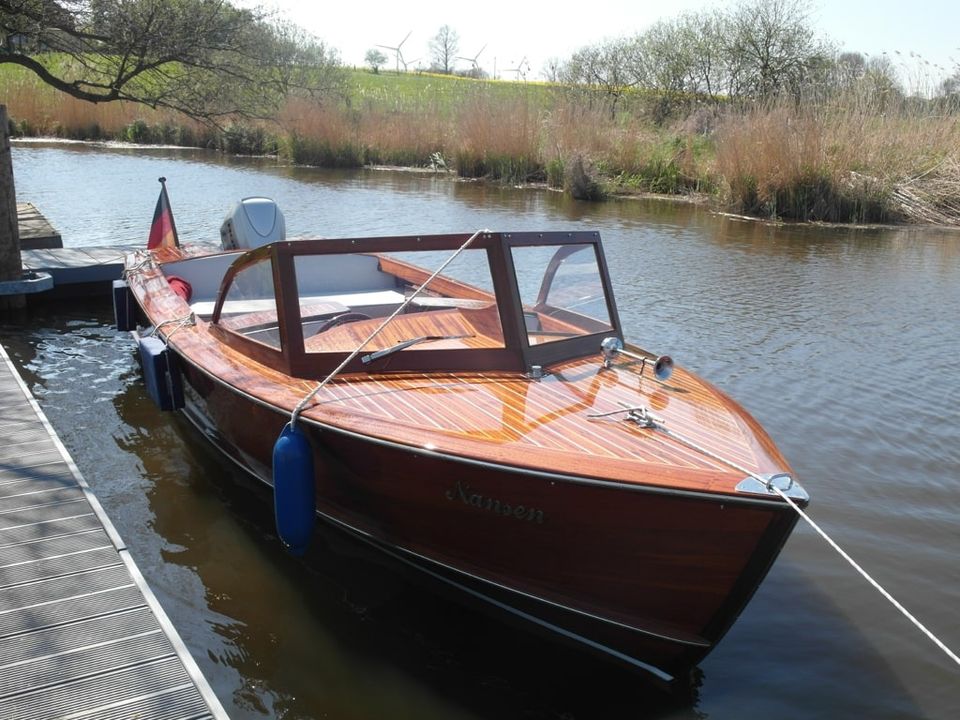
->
[294,250,504,363]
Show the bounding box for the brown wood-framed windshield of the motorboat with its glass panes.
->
[211,233,622,377]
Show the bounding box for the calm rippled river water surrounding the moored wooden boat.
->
[0,145,960,720]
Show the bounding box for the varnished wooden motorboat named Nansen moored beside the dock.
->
[124,197,807,683]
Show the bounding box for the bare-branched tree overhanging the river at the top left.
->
[0,0,342,306]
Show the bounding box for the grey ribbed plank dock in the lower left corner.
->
[0,347,227,720]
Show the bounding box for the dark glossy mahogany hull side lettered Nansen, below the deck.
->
[176,361,796,682]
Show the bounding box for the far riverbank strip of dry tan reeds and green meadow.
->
[0,63,960,224]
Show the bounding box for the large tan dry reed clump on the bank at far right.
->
[716,96,960,222]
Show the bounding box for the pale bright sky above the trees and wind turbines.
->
[255,0,960,87]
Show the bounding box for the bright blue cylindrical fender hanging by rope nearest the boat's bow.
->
[273,423,316,556]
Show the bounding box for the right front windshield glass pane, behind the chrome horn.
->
[511,244,613,345]
